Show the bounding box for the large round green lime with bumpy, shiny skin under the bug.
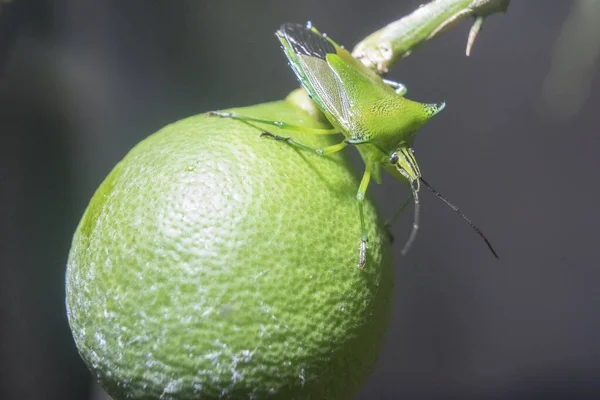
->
[66,101,393,400]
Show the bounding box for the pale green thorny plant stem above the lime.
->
[352,0,510,75]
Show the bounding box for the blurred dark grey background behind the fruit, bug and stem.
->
[0,0,600,399]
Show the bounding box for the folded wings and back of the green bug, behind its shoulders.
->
[277,23,395,130]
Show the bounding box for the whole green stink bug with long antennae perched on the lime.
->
[209,22,498,268]
